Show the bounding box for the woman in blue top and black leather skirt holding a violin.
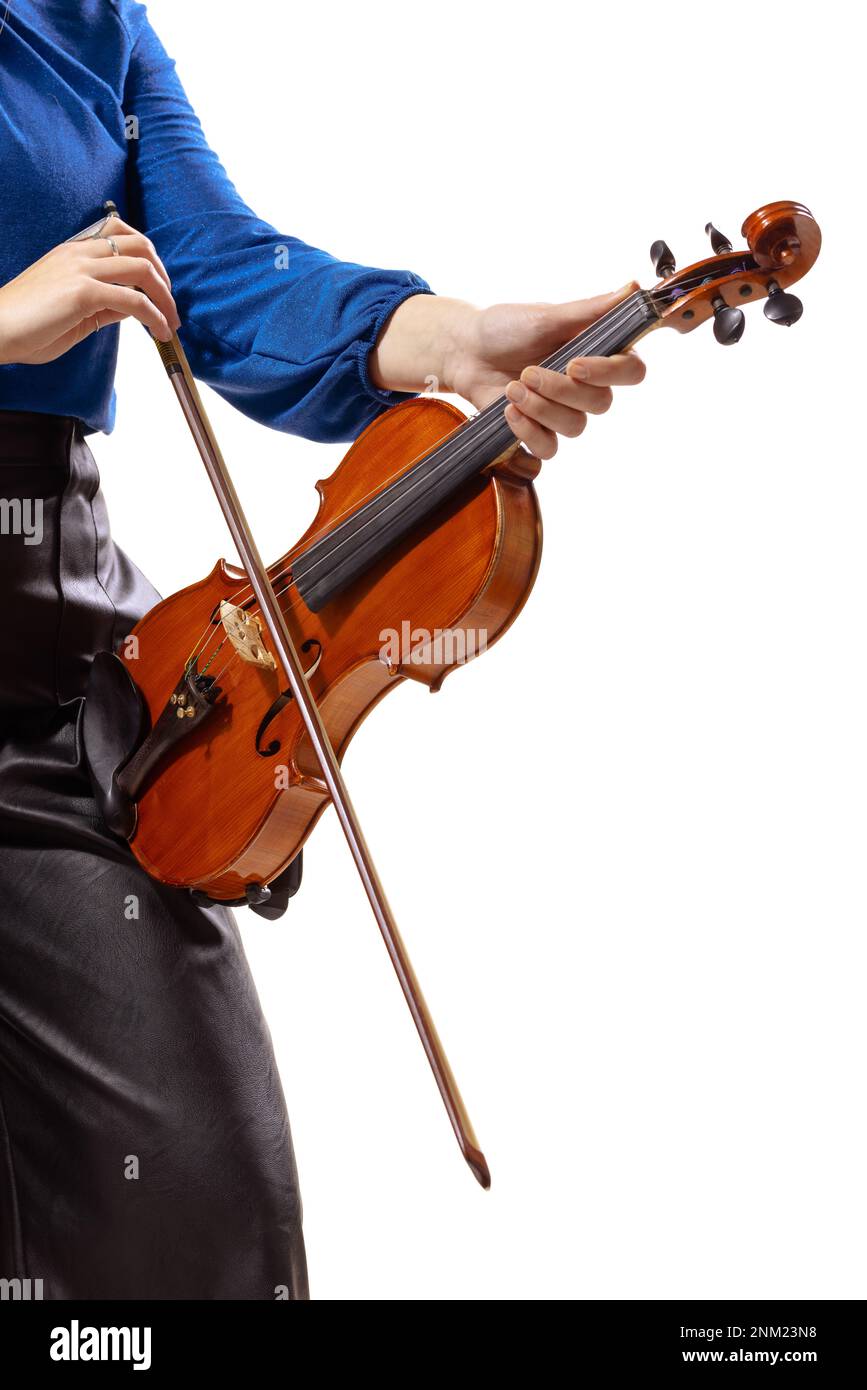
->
[0,0,643,1298]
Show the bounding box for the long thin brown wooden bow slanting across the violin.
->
[69,202,490,1188]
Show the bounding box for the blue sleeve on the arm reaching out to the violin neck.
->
[124,4,429,439]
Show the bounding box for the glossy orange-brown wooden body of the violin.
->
[121,396,542,901]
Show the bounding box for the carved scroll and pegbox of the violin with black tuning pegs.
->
[650,203,821,346]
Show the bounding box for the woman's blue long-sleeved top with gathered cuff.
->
[0,0,431,439]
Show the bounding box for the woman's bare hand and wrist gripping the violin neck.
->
[371,282,645,459]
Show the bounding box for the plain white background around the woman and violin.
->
[100,0,867,1300]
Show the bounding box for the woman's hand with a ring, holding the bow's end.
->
[0,217,181,366]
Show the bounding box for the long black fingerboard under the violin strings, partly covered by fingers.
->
[292,291,659,613]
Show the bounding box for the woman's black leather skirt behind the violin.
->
[0,411,307,1300]
